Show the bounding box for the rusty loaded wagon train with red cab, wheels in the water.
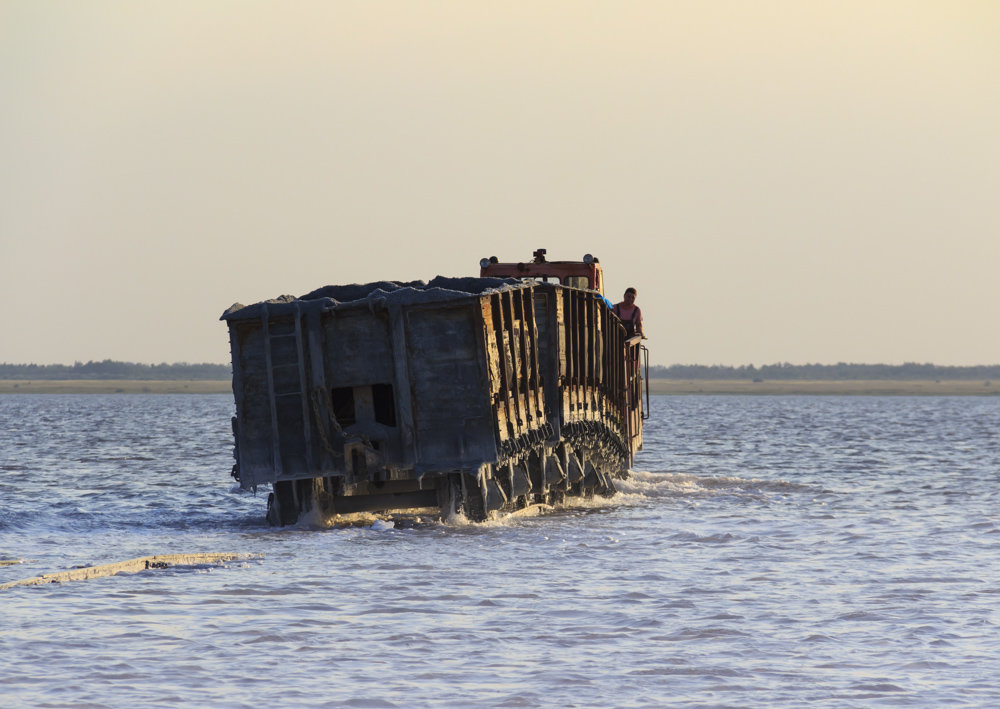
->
[222,249,648,525]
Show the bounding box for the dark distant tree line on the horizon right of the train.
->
[649,362,1000,381]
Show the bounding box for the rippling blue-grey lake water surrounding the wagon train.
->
[0,395,1000,707]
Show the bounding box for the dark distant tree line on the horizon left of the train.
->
[0,359,232,381]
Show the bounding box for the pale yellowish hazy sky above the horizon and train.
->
[0,0,1000,365]
